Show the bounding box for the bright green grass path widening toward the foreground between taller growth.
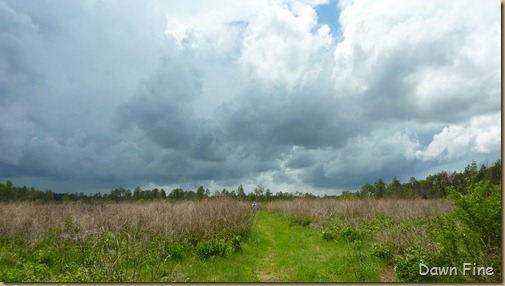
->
[171,211,385,282]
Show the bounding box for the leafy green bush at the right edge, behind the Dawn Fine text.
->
[394,181,502,282]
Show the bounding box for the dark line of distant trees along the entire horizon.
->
[0,159,496,202]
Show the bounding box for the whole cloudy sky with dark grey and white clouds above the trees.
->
[0,0,501,195]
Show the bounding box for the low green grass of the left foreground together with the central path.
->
[0,210,385,282]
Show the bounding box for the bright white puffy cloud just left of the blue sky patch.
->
[239,4,332,88]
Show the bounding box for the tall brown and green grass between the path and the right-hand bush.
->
[266,198,468,281]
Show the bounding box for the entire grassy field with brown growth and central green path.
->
[0,190,502,282]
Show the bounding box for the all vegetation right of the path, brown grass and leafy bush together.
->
[267,179,502,282]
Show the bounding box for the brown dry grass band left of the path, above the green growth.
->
[0,198,253,242]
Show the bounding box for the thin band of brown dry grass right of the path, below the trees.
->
[266,198,452,220]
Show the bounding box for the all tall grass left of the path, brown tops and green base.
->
[0,198,253,282]
